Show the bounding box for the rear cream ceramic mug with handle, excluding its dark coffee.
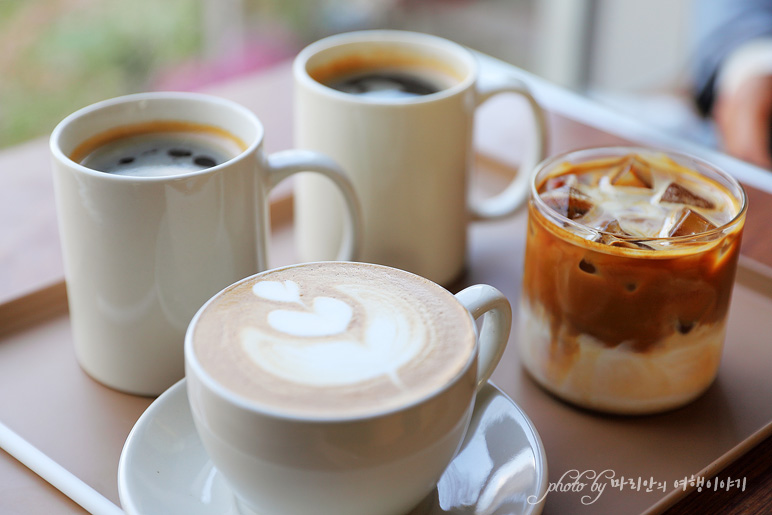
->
[293,30,546,285]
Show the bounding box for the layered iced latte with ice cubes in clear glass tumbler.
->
[519,147,746,413]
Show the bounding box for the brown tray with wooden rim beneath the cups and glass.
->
[0,157,772,513]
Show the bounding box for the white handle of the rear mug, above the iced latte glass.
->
[469,77,547,220]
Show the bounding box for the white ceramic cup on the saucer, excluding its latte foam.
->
[185,262,512,515]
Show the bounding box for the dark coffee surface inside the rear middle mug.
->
[327,71,445,99]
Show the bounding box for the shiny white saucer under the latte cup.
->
[118,379,547,515]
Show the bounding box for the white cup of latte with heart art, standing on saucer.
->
[185,262,511,515]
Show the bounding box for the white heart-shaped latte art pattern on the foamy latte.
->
[241,281,426,388]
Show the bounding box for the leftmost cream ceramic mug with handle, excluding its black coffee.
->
[51,92,360,395]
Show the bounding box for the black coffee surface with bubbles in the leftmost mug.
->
[71,121,246,177]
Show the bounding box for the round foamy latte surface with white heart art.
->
[193,263,474,417]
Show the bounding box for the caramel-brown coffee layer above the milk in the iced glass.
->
[524,198,740,354]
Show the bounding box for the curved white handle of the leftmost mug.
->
[267,149,362,261]
